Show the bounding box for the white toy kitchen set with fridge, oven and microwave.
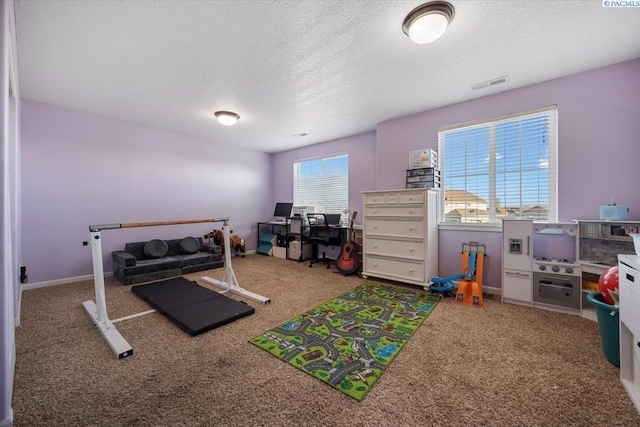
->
[502,219,640,321]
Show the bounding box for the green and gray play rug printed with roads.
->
[250,282,438,400]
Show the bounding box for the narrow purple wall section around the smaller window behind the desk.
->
[271,132,376,224]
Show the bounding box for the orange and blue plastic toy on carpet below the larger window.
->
[429,242,487,306]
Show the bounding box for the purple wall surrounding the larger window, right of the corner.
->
[375,59,640,288]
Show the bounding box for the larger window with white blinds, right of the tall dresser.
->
[438,106,557,223]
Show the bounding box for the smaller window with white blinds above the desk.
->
[293,154,349,213]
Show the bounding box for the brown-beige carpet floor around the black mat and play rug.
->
[13,255,640,427]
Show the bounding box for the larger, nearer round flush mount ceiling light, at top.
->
[402,1,455,44]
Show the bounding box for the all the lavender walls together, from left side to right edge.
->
[22,59,640,288]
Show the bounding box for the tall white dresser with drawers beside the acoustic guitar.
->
[362,188,438,286]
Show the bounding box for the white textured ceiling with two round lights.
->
[15,0,640,152]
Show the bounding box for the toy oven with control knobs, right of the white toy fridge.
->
[532,258,582,312]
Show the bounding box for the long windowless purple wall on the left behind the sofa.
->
[21,100,273,283]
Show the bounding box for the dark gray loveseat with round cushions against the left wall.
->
[111,237,224,285]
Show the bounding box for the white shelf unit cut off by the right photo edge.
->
[618,255,640,412]
